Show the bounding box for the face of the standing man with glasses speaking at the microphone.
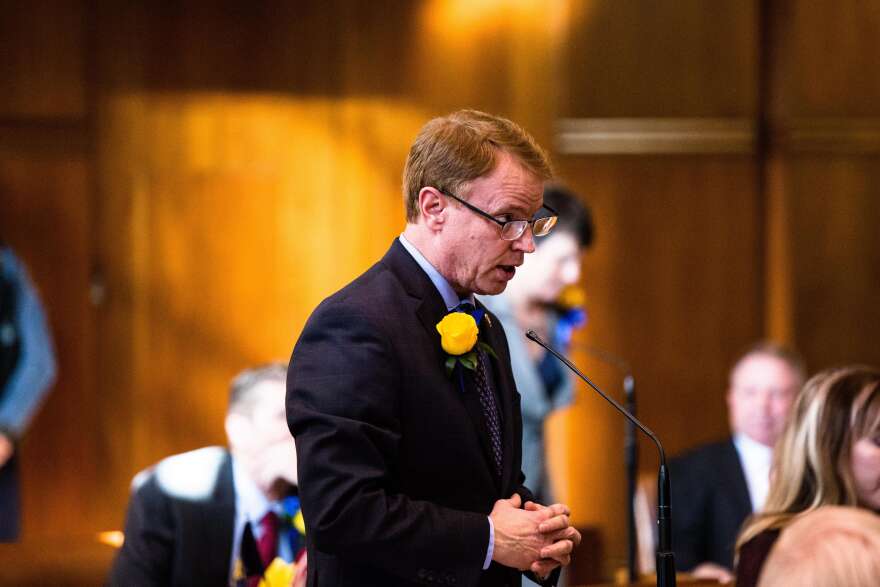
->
[439,152,543,295]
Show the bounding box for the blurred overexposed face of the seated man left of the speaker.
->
[226,381,297,494]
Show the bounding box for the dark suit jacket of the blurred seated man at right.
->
[669,440,752,571]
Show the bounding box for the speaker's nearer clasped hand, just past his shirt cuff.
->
[489,493,552,571]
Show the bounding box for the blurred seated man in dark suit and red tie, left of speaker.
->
[109,363,305,587]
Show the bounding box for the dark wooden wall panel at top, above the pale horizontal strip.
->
[560,0,759,118]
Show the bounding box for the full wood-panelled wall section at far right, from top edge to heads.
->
[767,0,880,371]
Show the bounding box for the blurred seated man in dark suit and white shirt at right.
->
[669,342,805,582]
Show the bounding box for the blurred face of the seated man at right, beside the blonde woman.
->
[727,354,800,447]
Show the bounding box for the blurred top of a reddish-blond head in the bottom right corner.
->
[758,506,880,587]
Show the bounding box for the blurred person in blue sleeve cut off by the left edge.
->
[0,241,55,542]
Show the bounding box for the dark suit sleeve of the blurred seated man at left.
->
[108,475,174,587]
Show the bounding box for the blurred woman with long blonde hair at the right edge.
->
[736,367,880,587]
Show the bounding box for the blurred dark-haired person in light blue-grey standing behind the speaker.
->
[480,185,593,503]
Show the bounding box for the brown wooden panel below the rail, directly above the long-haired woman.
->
[771,154,880,372]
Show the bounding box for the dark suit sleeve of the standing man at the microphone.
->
[287,303,489,584]
